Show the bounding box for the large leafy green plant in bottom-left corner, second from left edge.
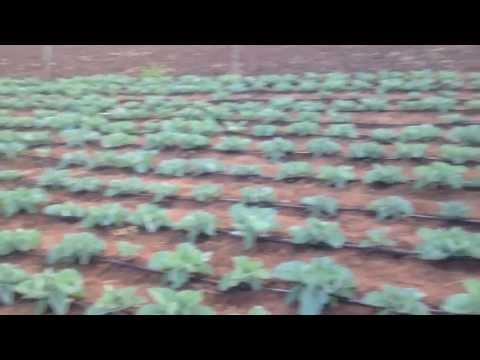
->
[15,269,84,315]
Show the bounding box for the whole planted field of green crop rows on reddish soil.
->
[0,70,480,315]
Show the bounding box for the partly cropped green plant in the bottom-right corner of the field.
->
[441,279,480,315]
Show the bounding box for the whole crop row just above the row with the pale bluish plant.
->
[5,169,480,224]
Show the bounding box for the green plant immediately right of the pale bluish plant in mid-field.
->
[289,218,346,249]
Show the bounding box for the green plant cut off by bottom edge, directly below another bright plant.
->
[137,288,215,315]
